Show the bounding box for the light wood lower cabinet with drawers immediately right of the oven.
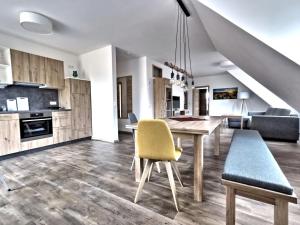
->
[52,111,72,144]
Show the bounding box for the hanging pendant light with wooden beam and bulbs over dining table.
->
[165,0,194,87]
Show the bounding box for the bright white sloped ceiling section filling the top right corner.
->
[197,0,300,65]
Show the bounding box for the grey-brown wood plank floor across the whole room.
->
[0,130,300,225]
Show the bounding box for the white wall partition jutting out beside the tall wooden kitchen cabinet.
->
[80,45,118,142]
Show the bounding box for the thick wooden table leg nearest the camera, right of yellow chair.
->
[194,134,204,202]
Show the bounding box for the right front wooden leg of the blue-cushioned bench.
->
[274,199,289,225]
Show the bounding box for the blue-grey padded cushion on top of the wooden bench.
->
[222,130,293,195]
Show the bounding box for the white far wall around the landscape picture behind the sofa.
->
[193,73,269,116]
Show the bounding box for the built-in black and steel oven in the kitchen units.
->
[20,112,53,142]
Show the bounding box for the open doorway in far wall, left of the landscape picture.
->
[193,86,209,116]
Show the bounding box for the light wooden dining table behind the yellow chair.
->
[126,116,222,202]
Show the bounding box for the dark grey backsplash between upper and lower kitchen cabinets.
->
[0,86,58,110]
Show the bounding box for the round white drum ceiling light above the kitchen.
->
[20,12,52,34]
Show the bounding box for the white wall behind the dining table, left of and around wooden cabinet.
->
[117,57,184,131]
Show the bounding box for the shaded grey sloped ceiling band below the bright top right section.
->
[193,0,300,111]
